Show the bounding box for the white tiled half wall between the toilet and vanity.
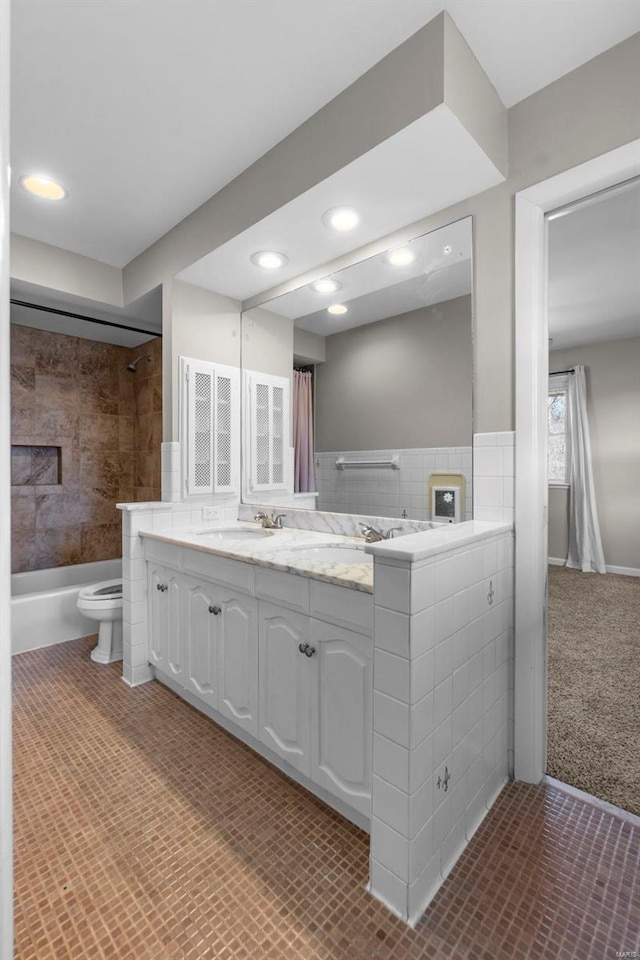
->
[118,498,238,687]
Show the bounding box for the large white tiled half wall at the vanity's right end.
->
[370,521,513,924]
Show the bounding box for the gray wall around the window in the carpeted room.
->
[549,337,640,569]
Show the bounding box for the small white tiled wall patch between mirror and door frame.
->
[473,430,515,523]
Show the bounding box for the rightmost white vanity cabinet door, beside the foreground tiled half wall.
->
[310,619,373,816]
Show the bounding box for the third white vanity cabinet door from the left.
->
[185,583,221,708]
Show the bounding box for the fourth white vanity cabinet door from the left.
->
[216,588,258,737]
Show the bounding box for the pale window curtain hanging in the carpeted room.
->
[567,366,607,573]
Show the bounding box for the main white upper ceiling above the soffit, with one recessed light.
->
[11,0,640,266]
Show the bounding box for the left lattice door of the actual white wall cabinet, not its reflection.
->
[185,360,215,496]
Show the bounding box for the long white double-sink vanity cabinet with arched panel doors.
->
[145,539,373,826]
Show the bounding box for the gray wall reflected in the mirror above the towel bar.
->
[316,296,472,451]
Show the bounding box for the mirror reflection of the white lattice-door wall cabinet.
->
[245,371,290,492]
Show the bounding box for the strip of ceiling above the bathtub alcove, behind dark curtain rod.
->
[11,280,162,347]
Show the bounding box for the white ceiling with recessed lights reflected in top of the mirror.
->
[258,217,472,336]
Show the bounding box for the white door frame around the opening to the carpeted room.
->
[514,139,640,783]
